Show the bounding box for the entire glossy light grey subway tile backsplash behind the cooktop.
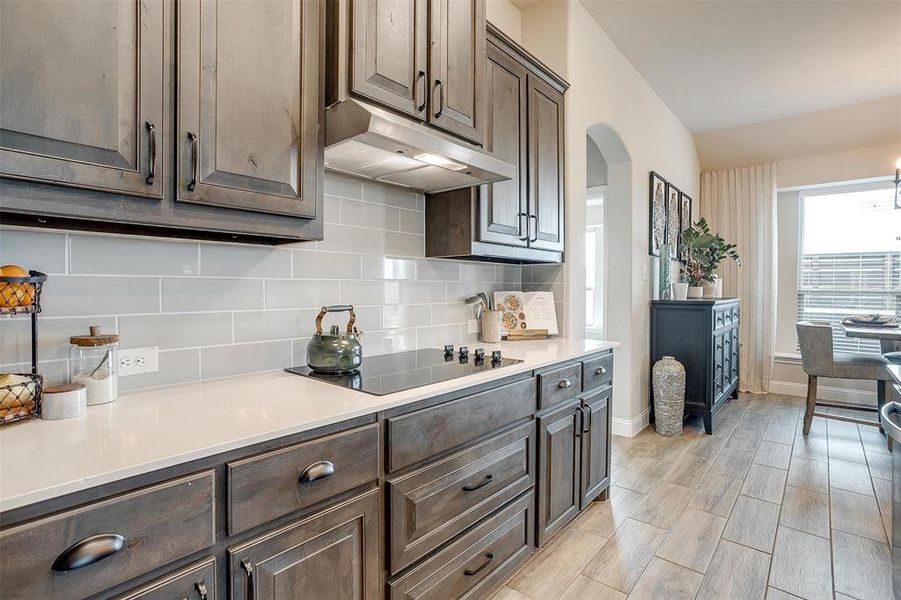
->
[0,173,536,391]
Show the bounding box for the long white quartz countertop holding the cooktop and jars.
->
[0,338,618,512]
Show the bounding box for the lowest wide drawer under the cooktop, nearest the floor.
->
[388,493,534,600]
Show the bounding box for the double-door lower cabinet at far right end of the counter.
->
[537,386,612,546]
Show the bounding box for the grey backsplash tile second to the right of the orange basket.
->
[163,278,263,312]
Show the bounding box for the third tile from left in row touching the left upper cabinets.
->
[200,244,291,277]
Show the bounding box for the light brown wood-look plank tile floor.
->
[494,394,892,600]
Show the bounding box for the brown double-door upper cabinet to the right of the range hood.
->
[426,24,569,263]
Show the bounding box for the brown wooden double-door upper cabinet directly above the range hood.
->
[327,0,486,145]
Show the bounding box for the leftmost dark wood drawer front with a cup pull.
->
[0,471,215,600]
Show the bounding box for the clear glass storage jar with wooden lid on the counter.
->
[69,325,119,406]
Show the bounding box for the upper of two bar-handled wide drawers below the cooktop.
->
[388,422,535,573]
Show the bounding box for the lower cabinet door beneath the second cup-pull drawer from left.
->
[228,490,381,600]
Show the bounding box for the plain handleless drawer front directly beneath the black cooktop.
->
[386,379,535,471]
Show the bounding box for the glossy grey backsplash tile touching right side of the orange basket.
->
[41,275,160,317]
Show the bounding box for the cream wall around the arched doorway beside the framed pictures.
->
[522,0,699,431]
